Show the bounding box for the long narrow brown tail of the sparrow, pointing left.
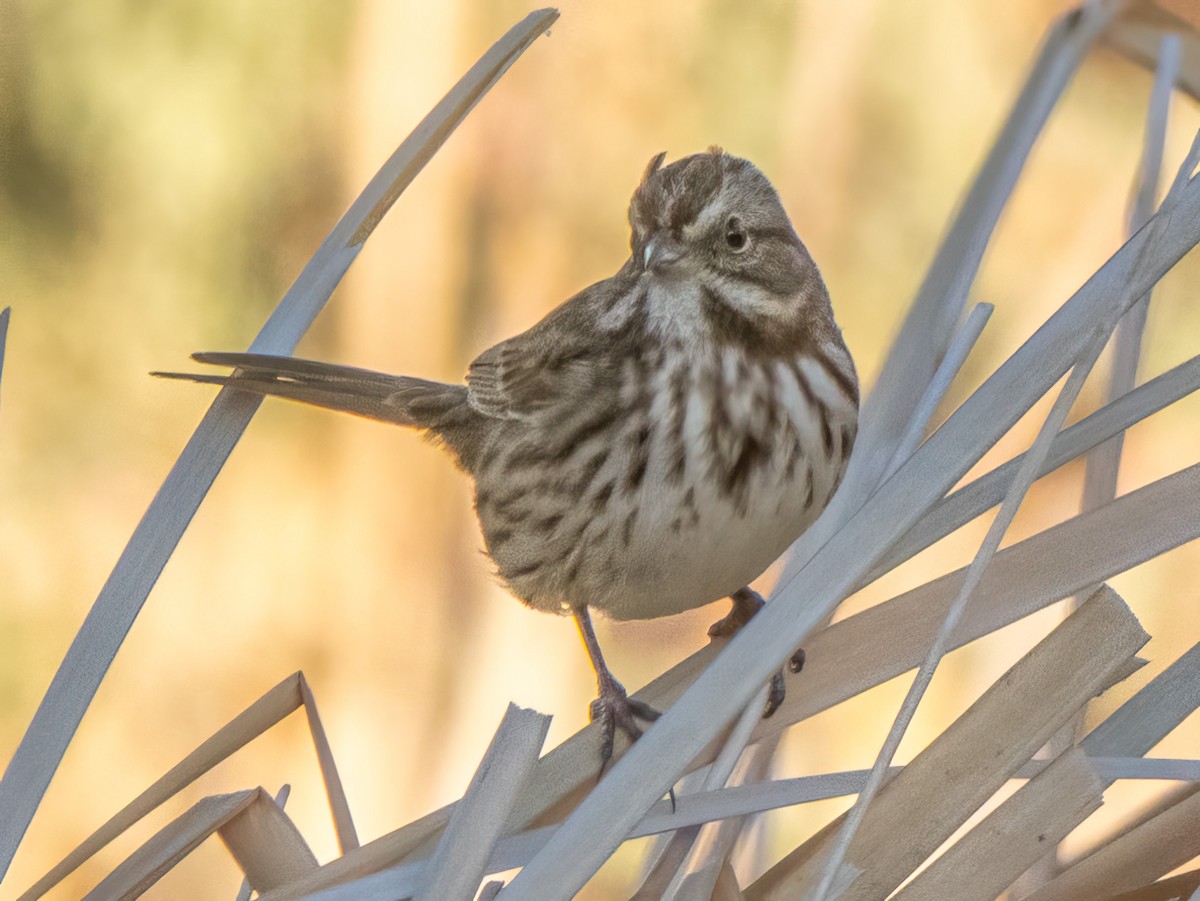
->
[158,353,473,434]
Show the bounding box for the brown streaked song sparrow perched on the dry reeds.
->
[156,148,858,761]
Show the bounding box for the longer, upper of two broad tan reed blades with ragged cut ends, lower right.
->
[745,587,1150,901]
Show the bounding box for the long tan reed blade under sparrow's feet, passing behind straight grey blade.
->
[264,464,1200,901]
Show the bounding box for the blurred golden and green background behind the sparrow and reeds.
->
[0,0,1200,899]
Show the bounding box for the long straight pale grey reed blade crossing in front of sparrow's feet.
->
[502,149,1200,901]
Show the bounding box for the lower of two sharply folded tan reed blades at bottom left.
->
[84,788,317,901]
